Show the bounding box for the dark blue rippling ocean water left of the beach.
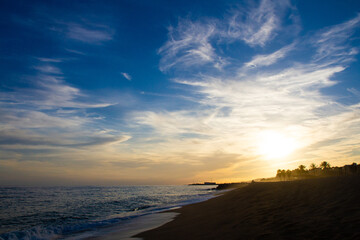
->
[0,186,214,240]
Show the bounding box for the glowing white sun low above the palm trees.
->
[257,131,297,160]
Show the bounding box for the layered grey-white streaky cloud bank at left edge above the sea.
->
[0,59,122,159]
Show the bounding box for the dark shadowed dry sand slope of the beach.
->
[136,177,360,240]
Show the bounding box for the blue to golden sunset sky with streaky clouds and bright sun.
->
[0,0,360,185]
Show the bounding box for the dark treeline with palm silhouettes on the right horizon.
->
[276,161,360,181]
